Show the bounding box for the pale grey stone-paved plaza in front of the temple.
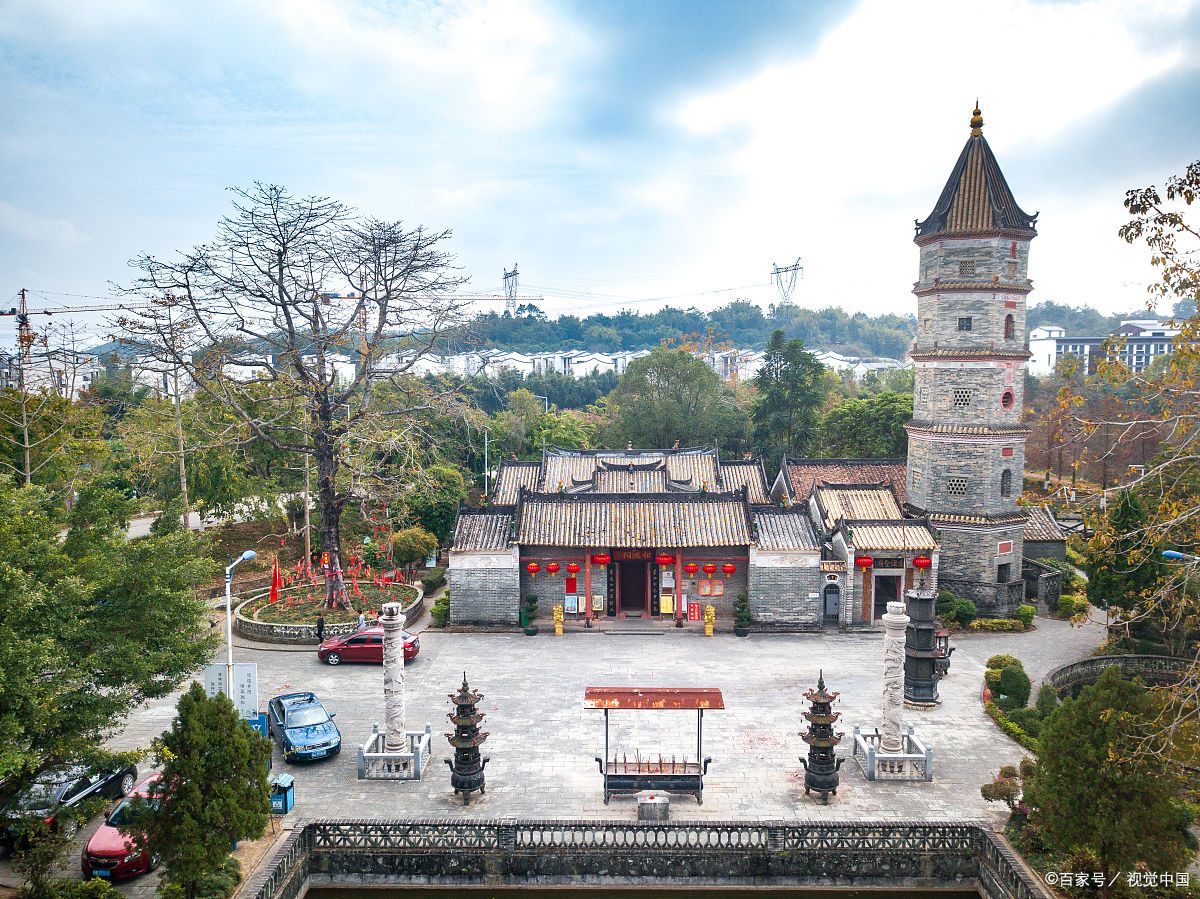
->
[0,618,1103,895]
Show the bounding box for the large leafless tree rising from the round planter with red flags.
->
[120,184,466,606]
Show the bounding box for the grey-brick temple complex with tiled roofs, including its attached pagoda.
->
[449,107,1062,630]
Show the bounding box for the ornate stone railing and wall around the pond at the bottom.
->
[238,820,1050,899]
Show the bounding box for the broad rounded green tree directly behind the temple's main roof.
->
[605,348,749,453]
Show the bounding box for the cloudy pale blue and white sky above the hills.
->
[0,0,1200,344]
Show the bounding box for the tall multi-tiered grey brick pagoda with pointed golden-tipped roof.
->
[907,106,1037,616]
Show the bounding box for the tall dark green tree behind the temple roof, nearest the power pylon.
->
[752,329,826,461]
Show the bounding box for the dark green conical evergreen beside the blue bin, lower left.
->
[131,683,271,899]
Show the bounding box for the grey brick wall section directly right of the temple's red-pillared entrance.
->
[749,549,824,630]
